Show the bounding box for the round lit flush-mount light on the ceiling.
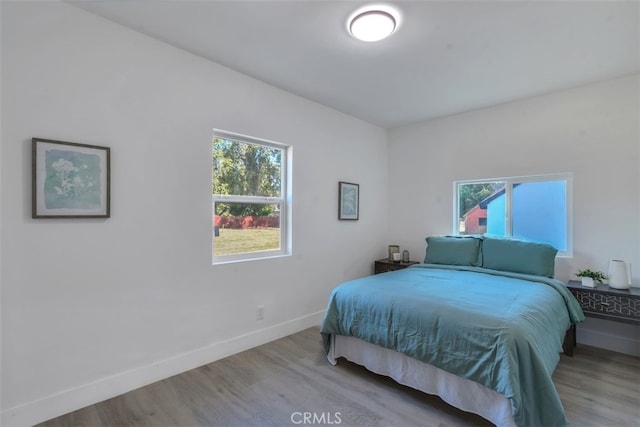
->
[347,5,400,42]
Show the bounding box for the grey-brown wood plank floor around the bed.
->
[40,328,640,427]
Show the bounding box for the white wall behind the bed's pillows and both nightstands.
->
[389,75,640,355]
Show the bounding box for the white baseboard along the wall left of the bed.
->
[0,310,324,427]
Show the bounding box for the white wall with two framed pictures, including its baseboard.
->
[0,2,388,425]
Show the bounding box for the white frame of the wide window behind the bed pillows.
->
[453,172,573,258]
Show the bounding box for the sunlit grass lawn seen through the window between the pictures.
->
[214,228,280,256]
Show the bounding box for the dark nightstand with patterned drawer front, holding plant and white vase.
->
[565,280,640,355]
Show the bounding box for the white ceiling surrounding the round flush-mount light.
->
[69,0,640,128]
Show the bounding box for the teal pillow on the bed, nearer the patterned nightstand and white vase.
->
[482,236,558,277]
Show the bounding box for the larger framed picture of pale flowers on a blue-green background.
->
[31,138,111,218]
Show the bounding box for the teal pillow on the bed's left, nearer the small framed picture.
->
[424,236,481,267]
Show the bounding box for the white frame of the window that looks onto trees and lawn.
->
[211,129,293,265]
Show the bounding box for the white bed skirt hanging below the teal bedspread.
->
[327,335,516,427]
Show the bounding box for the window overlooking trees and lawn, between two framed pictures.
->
[212,130,291,264]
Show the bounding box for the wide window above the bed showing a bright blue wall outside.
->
[454,174,573,256]
